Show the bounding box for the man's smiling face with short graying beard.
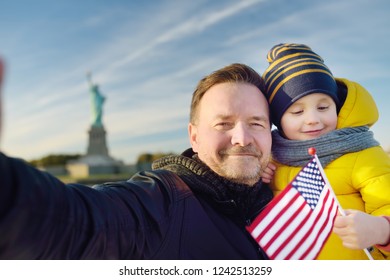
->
[189,83,271,186]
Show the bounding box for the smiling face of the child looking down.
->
[281,93,337,140]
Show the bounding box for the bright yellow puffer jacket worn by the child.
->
[271,79,390,260]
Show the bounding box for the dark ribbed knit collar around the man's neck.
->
[152,149,273,220]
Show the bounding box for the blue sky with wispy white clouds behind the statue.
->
[0,0,390,163]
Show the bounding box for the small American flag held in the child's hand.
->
[247,156,339,260]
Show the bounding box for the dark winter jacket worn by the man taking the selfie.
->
[0,151,272,259]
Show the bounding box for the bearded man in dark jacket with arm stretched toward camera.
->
[0,60,272,259]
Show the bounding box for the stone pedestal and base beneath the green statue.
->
[67,126,124,178]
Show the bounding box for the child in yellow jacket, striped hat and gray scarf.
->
[263,44,390,259]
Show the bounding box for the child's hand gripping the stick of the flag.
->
[333,210,390,249]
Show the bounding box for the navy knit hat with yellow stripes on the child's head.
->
[263,44,339,130]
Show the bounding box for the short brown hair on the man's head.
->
[190,63,264,124]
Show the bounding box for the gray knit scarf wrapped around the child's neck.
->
[272,126,379,167]
